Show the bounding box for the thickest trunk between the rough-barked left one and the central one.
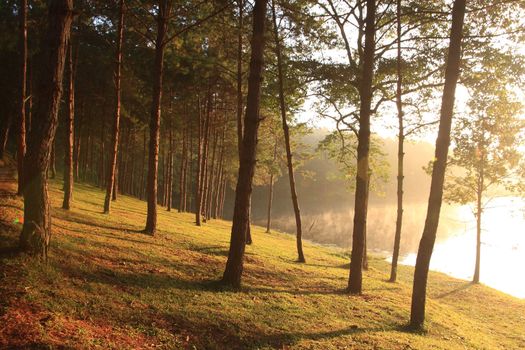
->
[144,0,171,235]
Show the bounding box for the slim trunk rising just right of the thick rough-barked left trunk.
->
[62,39,75,210]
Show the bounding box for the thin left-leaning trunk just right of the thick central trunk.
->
[272,0,306,263]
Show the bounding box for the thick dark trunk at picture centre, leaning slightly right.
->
[222,0,267,288]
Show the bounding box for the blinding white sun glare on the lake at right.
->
[401,197,525,298]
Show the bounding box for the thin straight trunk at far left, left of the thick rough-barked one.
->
[17,0,27,195]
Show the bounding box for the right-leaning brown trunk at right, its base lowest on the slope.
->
[410,0,466,329]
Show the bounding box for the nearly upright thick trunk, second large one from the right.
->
[348,0,376,294]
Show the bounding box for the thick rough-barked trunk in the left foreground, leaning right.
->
[20,0,73,260]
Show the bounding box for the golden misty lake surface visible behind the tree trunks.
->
[258,197,525,298]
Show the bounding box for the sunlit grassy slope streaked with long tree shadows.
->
[0,182,525,349]
